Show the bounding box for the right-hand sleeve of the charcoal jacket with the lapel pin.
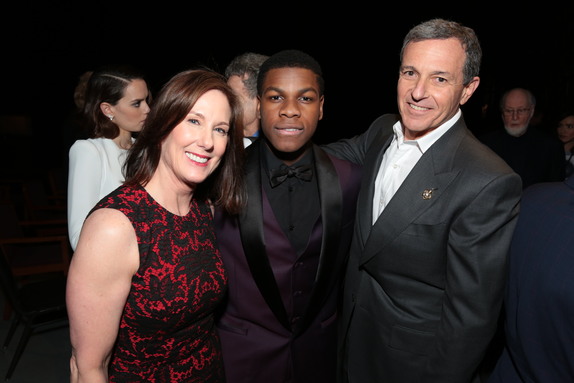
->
[426,173,521,382]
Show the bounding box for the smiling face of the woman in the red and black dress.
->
[158,90,231,185]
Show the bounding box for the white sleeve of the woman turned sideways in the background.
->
[68,140,102,250]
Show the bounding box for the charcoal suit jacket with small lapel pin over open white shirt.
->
[328,115,521,383]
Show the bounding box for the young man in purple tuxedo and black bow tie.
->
[215,50,361,383]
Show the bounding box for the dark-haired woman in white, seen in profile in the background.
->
[68,66,150,250]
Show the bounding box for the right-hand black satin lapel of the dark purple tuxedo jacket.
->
[296,145,343,332]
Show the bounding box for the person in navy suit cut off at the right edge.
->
[489,176,574,383]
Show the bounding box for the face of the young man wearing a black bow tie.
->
[258,67,324,165]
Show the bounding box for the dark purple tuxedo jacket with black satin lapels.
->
[215,139,361,383]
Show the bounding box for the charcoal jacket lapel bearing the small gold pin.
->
[360,123,466,264]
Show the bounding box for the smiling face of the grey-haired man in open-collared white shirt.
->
[397,38,480,140]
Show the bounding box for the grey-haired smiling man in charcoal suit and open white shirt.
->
[327,19,522,383]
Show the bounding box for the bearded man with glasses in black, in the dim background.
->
[482,88,564,188]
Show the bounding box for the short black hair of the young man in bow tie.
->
[257,49,325,96]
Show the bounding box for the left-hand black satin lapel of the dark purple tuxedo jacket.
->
[239,140,291,331]
